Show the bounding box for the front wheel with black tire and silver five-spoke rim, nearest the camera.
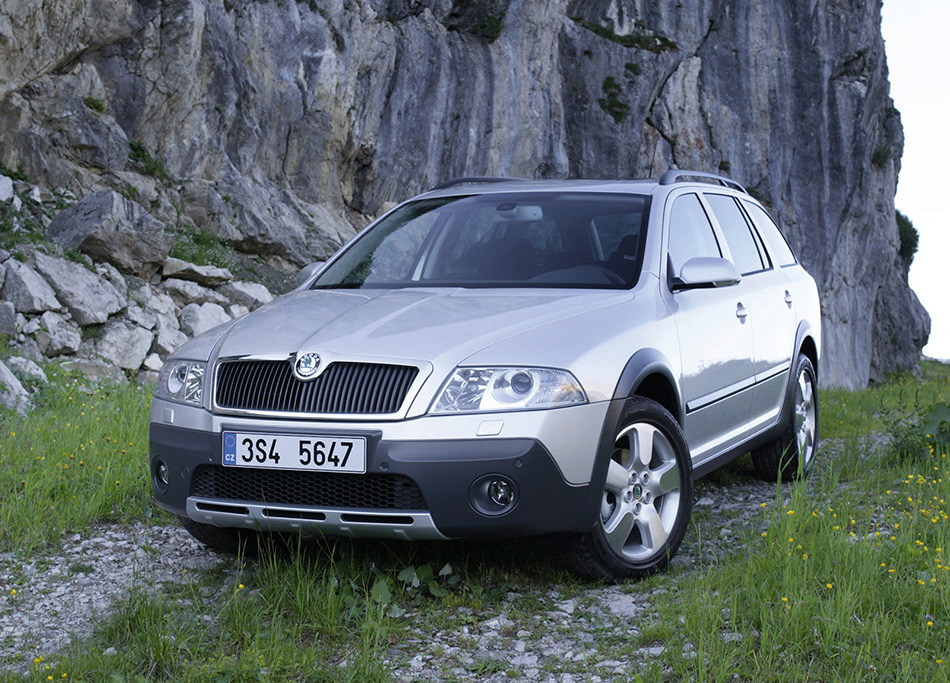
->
[563,396,693,582]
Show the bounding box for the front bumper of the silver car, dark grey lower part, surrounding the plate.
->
[149,405,601,539]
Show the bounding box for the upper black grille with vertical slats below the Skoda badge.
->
[215,360,419,415]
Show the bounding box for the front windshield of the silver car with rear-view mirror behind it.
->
[312,192,649,289]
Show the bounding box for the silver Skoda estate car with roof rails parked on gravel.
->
[150,171,821,580]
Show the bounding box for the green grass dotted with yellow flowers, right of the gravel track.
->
[652,363,950,681]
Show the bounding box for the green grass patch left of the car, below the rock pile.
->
[0,365,151,552]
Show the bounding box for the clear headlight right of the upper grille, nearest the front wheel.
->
[430,368,587,415]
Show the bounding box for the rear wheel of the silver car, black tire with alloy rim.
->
[752,354,818,481]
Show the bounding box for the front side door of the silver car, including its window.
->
[666,192,754,464]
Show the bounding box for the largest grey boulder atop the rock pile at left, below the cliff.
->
[46,190,175,279]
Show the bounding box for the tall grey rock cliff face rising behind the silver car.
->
[0,0,929,387]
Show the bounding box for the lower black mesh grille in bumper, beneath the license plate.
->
[193,465,429,510]
